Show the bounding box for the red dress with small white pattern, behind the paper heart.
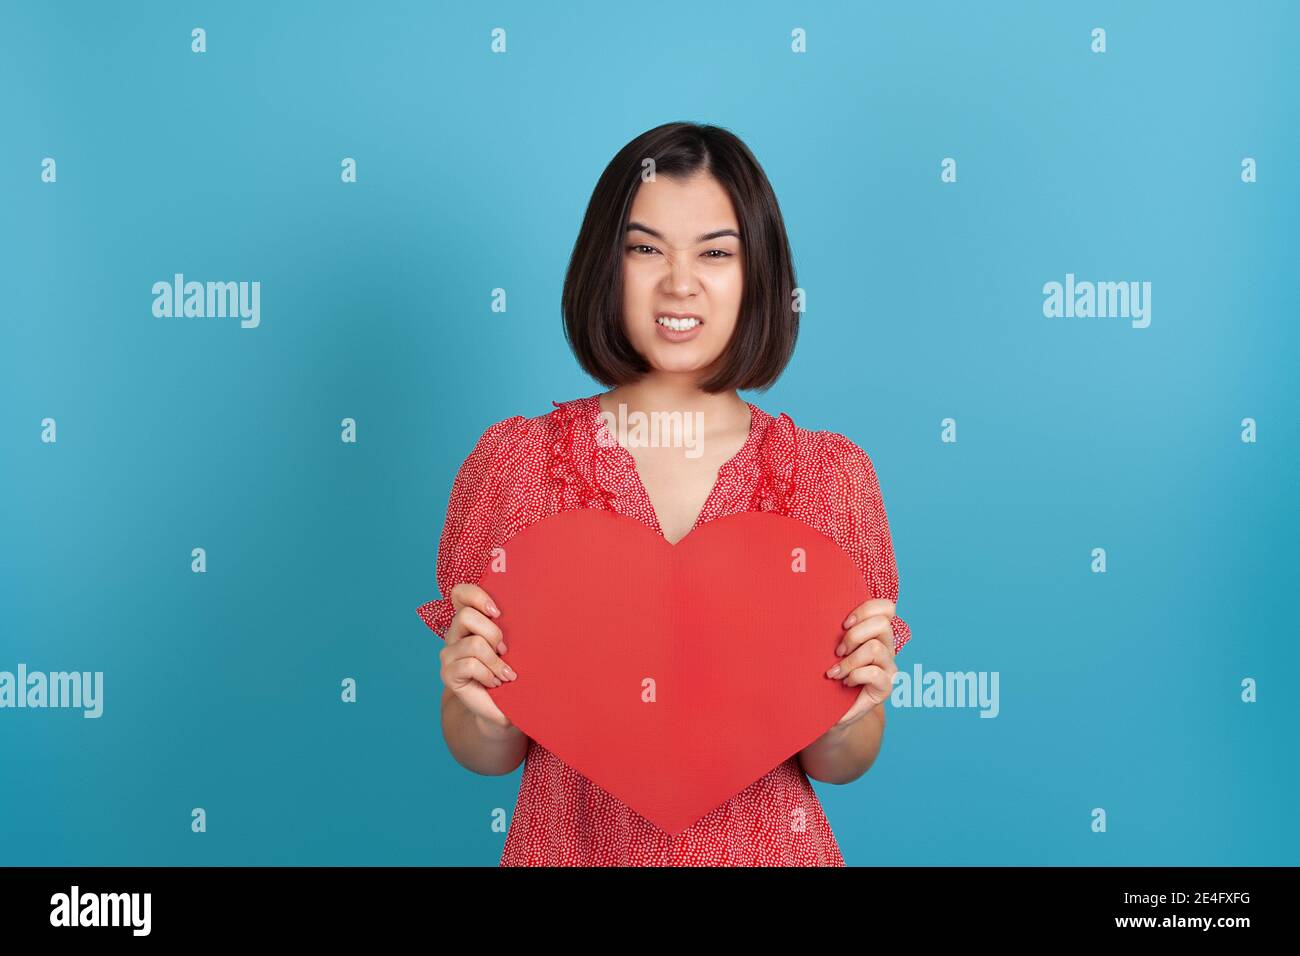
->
[417,395,911,866]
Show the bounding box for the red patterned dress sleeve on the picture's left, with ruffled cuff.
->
[416,415,525,640]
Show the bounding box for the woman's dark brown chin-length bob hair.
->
[560,122,800,392]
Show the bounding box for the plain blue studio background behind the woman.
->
[0,3,1300,865]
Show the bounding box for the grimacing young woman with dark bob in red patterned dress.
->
[419,122,910,866]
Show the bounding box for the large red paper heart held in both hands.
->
[478,509,870,834]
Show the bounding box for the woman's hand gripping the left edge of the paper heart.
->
[438,583,517,728]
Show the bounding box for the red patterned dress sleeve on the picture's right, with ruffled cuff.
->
[822,432,911,654]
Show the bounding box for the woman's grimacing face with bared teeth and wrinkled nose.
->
[623,173,745,382]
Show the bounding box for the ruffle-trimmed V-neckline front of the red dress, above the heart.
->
[549,394,800,527]
